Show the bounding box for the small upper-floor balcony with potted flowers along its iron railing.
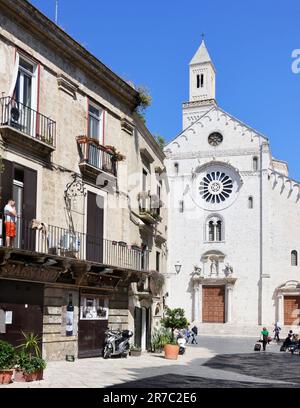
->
[76,136,118,179]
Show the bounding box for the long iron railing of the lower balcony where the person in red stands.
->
[0,218,149,271]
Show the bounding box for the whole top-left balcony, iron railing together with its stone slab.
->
[0,97,56,157]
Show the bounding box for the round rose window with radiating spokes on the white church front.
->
[199,171,233,204]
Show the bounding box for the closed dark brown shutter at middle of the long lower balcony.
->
[86,191,104,262]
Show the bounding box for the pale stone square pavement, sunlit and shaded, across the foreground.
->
[0,336,300,388]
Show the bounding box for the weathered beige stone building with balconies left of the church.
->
[0,0,168,359]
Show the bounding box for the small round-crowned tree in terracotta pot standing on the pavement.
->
[161,308,189,360]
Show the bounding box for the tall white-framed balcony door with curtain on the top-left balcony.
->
[12,58,37,137]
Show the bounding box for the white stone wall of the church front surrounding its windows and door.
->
[166,105,300,325]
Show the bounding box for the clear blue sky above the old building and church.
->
[31,0,300,179]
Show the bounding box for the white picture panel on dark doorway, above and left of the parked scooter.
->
[80,297,108,320]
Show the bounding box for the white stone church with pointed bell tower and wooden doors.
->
[165,41,300,335]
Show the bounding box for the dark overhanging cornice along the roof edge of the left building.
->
[0,0,139,110]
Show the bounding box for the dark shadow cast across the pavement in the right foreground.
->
[108,352,300,388]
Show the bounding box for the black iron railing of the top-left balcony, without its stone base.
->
[0,96,56,148]
